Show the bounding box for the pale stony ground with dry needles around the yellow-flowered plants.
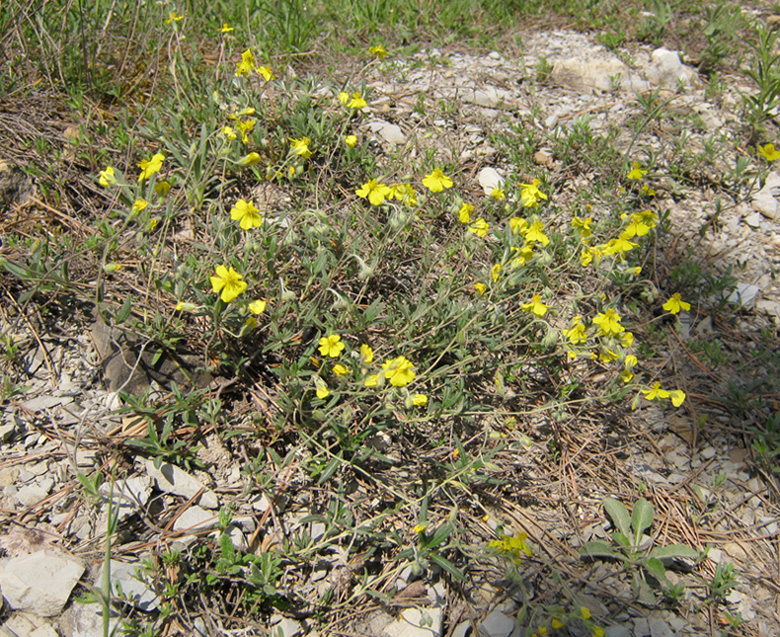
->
[0,19,780,637]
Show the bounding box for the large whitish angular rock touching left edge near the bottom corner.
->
[0,550,84,617]
